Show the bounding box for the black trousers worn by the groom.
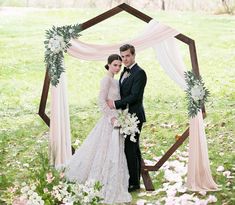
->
[125,123,143,186]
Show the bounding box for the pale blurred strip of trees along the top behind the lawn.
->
[0,0,235,14]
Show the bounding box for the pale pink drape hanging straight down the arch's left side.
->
[49,73,72,168]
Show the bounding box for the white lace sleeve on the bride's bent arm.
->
[98,77,116,122]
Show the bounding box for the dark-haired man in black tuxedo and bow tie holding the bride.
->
[108,44,147,192]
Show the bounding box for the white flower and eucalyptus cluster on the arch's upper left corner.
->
[44,24,81,86]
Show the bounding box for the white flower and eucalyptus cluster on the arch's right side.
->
[185,71,210,118]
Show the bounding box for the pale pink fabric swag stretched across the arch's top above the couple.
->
[67,20,179,60]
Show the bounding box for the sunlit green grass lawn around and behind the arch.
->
[0,9,235,204]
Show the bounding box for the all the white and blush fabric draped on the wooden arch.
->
[50,20,217,191]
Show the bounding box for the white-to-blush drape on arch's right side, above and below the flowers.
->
[154,38,217,191]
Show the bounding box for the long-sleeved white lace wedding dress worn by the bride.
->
[65,76,131,204]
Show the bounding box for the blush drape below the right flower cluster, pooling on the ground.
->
[187,111,218,191]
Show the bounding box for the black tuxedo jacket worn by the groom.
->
[114,64,147,123]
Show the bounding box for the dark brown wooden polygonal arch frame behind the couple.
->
[38,3,206,191]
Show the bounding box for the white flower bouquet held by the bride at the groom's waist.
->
[114,109,140,142]
